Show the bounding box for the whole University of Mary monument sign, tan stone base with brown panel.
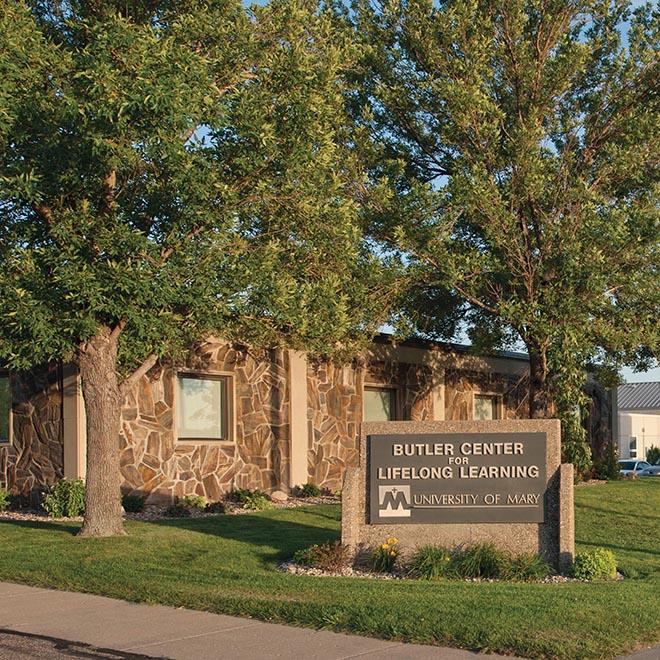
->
[342,420,574,570]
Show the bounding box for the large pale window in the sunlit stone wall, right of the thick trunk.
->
[176,374,232,441]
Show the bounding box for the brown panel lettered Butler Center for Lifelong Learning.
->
[367,433,547,525]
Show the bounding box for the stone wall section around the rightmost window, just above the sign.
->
[445,369,529,421]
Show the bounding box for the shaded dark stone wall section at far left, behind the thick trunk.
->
[0,363,64,499]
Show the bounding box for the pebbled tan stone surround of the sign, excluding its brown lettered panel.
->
[342,420,573,568]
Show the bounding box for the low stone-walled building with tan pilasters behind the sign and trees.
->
[0,336,608,501]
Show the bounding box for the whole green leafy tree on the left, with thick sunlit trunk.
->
[0,0,381,536]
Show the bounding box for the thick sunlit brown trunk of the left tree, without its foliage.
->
[78,327,124,537]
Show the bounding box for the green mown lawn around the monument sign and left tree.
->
[0,479,660,658]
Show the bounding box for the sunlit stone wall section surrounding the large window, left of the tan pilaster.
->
[120,341,289,502]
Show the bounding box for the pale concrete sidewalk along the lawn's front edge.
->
[0,582,660,660]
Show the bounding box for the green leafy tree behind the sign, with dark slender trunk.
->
[344,0,660,468]
